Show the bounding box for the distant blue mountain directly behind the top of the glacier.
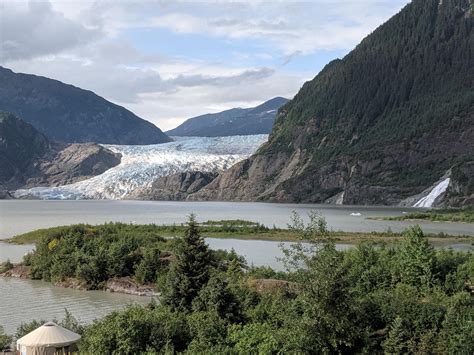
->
[166,97,288,137]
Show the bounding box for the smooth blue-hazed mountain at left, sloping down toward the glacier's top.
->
[0,67,170,144]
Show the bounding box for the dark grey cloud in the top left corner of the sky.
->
[0,1,102,62]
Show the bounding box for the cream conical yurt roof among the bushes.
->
[16,322,81,347]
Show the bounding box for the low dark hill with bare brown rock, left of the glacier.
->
[0,112,120,190]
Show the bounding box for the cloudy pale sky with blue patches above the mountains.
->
[0,0,408,130]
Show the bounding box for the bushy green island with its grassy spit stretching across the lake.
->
[0,214,474,296]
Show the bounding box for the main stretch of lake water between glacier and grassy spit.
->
[0,200,474,239]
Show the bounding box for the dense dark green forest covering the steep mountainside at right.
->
[264,0,474,197]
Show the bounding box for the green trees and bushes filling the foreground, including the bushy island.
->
[1,215,474,354]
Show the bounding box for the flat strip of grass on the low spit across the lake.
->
[8,220,474,244]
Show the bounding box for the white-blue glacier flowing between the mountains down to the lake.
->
[14,134,268,200]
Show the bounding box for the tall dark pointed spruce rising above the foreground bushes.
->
[163,214,211,310]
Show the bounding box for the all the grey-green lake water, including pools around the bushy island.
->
[0,200,474,333]
